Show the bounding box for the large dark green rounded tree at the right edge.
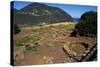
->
[70,11,97,36]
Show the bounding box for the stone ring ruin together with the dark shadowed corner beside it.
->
[63,42,97,62]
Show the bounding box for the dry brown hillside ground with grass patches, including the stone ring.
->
[14,23,96,65]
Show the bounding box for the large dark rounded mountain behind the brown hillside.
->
[14,3,73,25]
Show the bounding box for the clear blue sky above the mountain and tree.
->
[11,1,97,18]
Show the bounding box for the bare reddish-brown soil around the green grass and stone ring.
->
[14,22,96,65]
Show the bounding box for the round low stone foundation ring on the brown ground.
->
[64,42,86,60]
